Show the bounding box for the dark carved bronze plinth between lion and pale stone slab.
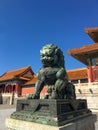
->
[11,99,92,126]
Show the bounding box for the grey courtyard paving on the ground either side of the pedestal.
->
[0,105,98,130]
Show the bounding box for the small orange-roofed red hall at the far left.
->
[0,66,35,96]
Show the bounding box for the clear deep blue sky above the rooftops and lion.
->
[0,0,98,75]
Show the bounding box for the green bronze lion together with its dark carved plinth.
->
[11,44,91,126]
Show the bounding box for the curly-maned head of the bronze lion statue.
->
[40,44,64,68]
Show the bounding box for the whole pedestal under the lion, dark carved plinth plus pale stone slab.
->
[6,99,96,130]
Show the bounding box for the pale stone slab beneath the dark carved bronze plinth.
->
[6,115,97,130]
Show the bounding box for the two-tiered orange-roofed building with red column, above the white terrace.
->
[68,28,98,82]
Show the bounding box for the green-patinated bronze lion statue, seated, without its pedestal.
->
[28,44,76,99]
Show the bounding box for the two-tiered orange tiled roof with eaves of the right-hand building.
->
[68,27,98,65]
